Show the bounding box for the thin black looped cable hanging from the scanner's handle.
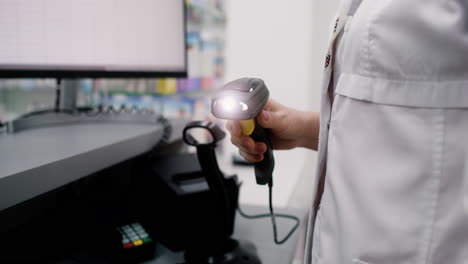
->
[237,182,301,245]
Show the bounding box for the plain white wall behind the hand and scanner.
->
[226,0,338,207]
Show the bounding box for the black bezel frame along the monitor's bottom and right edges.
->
[0,0,188,79]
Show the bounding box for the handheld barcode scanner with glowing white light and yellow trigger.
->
[211,78,275,186]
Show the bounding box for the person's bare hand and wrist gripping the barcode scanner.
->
[226,99,319,162]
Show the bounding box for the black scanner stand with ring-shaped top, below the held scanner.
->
[183,121,261,264]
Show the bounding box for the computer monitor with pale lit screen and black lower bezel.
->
[0,0,187,77]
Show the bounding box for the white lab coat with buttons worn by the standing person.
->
[305,0,468,264]
